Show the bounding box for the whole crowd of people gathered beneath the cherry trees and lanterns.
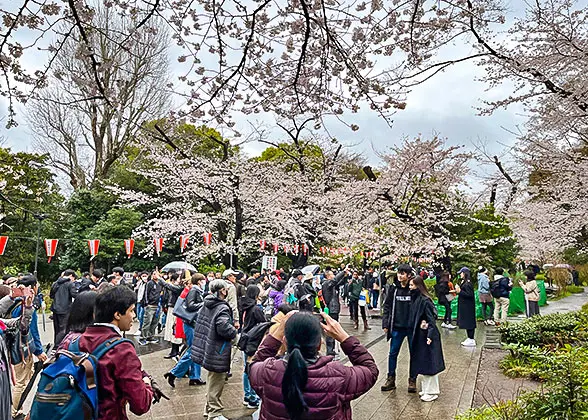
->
[0,264,552,420]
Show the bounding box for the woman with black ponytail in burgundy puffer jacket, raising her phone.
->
[249,312,378,420]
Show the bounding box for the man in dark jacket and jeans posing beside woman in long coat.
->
[381,264,416,393]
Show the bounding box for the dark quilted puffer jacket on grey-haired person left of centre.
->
[191,295,237,373]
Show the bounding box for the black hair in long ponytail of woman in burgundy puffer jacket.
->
[282,312,322,420]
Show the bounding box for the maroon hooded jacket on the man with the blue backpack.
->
[79,325,153,420]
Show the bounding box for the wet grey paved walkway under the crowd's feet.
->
[25,293,588,420]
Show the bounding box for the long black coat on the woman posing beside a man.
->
[409,291,445,377]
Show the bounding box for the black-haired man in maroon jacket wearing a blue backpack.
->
[79,286,154,420]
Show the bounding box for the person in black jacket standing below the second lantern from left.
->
[49,270,78,348]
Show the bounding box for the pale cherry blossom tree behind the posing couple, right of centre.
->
[326,137,471,270]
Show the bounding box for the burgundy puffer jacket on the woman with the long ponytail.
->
[249,335,379,420]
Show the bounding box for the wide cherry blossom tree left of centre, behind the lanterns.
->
[118,126,330,266]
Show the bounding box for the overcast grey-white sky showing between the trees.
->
[0,0,525,174]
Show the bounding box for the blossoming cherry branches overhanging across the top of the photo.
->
[0,0,503,129]
